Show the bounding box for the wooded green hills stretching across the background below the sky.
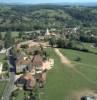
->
[0,3,97,31]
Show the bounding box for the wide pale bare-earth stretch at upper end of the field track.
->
[54,48,74,68]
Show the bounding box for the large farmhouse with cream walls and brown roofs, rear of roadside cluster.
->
[16,50,43,73]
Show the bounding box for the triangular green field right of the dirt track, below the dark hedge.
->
[60,49,97,84]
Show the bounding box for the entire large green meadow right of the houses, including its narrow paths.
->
[40,48,97,100]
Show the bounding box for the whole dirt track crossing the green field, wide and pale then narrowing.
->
[54,48,97,85]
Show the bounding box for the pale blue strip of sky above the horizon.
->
[0,0,97,4]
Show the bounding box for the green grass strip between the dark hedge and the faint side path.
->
[60,49,97,66]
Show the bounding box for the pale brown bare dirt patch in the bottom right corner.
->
[72,89,97,100]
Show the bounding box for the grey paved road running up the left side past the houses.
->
[2,49,15,100]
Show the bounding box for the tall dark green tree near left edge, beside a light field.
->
[4,32,14,48]
